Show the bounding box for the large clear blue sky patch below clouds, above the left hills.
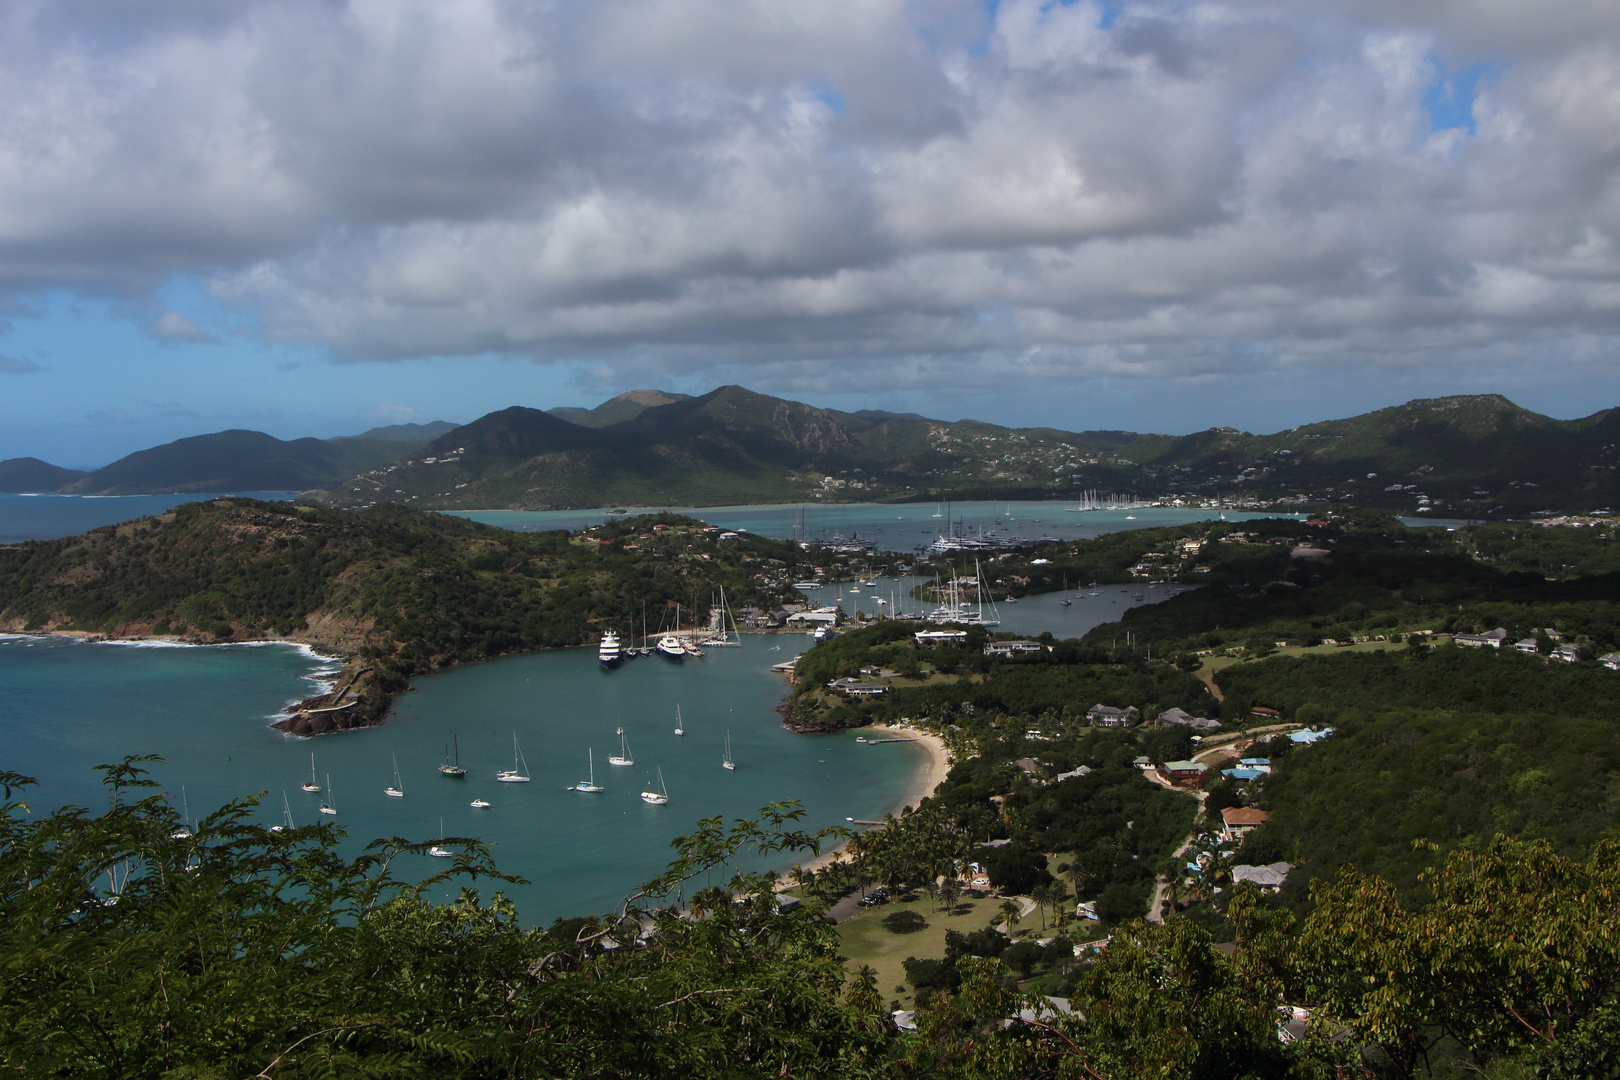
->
[0,279,586,468]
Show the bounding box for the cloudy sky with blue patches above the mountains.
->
[0,0,1620,468]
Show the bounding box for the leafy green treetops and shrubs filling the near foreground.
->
[0,759,1620,1080]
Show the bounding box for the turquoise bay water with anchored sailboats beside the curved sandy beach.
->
[0,636,927,925]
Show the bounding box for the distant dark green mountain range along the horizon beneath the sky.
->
[0,393,1620,517]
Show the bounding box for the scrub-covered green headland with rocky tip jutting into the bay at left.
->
[0,498,812,733]
